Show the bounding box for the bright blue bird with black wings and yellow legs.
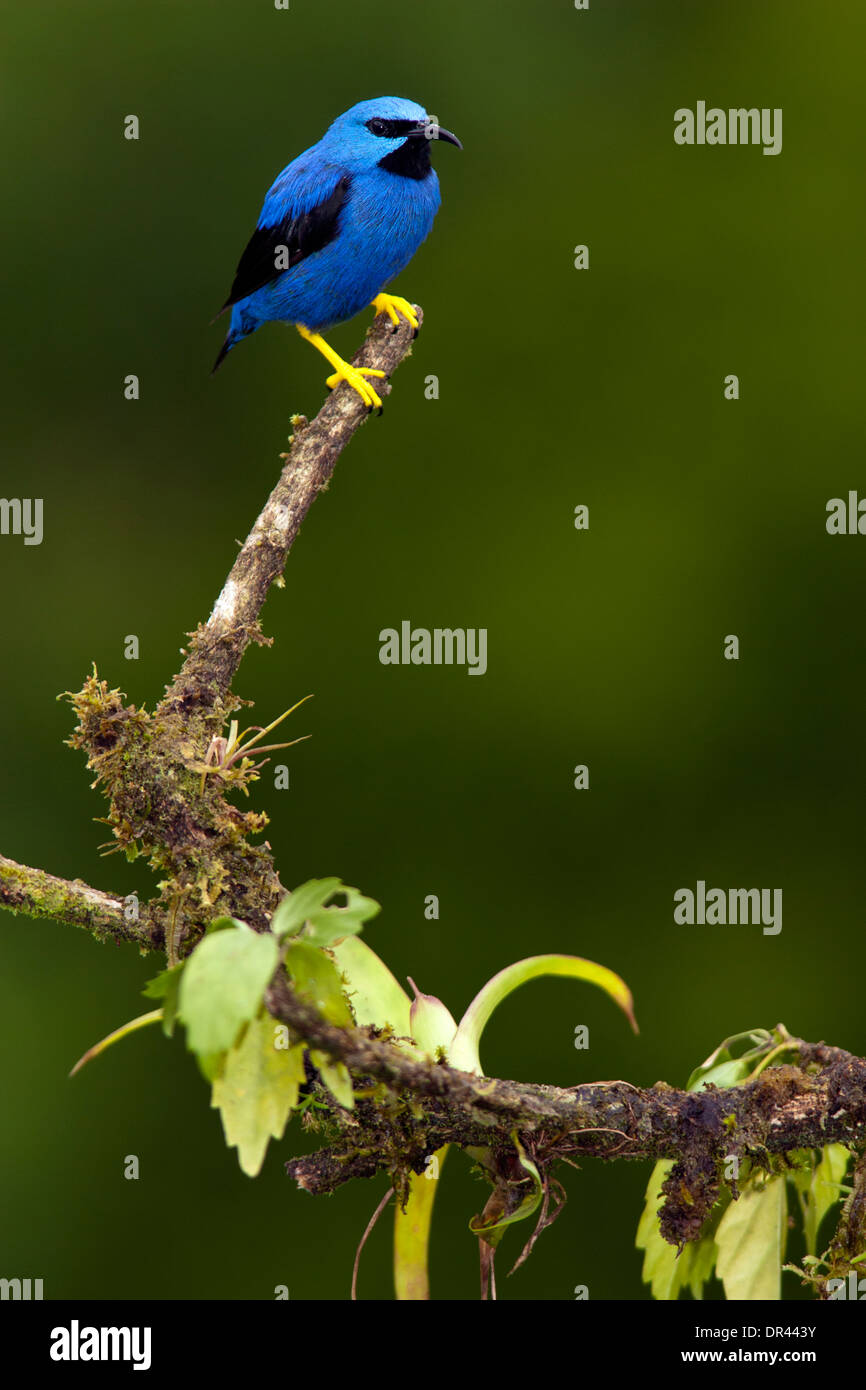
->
[213,96,463,410]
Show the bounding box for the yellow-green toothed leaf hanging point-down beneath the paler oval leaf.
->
[211,1012,304,1177]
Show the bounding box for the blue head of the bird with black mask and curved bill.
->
[325,96,463,178]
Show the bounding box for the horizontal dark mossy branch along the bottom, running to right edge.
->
[265,974,866,1244]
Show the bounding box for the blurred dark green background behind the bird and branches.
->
[0,0,866,1300]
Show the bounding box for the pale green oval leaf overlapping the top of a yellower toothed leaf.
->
[178,922,279,1070]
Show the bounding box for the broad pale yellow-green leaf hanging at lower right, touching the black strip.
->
[716,1173,788,1301]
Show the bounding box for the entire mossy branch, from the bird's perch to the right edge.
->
[0,311,866,1289]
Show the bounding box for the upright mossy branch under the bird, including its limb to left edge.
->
[0,310,423,958]
